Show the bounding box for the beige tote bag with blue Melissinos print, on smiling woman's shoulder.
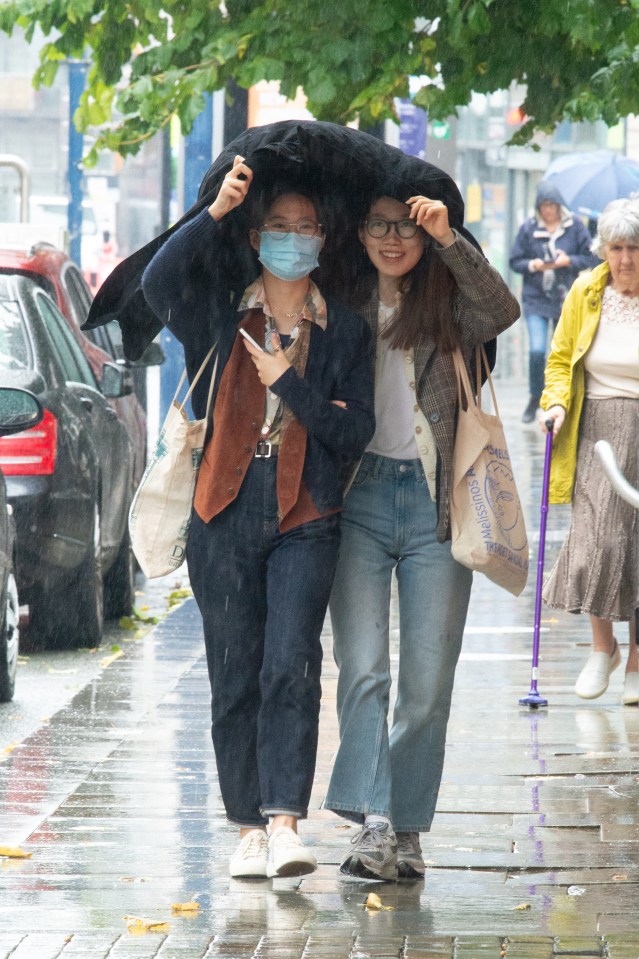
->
[450,347,528,596]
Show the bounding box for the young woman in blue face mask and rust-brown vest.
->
[143,157,374,878]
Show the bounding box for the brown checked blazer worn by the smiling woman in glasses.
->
[360,231,520,543]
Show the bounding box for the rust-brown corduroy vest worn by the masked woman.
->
[193,310,337,532]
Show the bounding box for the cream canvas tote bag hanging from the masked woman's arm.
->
[129,343,218,579]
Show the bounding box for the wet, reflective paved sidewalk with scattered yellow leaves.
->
[0,381,639,959]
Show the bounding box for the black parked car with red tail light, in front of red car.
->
[0,274,134,647]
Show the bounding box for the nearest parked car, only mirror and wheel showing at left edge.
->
[0,387,44,703]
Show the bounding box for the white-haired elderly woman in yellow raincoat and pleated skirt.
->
[539,199,639,705]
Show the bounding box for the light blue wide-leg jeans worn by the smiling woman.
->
[325,453,472,832]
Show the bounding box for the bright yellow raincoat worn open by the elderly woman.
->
[539,263,610,503]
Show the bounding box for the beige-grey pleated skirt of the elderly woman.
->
[542,399,639,621]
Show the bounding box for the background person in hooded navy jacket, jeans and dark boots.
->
[509,180,599,423]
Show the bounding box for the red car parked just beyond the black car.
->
[0,240,164,484]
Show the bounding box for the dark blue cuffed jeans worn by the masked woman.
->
[187,458,339,826]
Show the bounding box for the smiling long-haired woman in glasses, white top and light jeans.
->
[325,196,519,880]
